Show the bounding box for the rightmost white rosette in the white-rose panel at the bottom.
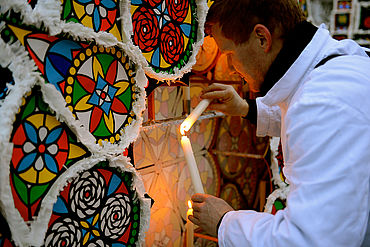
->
[100,194,132,239]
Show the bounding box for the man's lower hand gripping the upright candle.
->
[189,194,234,237]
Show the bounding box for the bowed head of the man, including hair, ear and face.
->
[206,0,305,91]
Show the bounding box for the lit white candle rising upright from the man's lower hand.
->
[181,136,204,194]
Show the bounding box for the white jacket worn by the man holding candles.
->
[218,27,370,247]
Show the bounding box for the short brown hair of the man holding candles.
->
[206,0,306,44]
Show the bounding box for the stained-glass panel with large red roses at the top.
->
[131,0,198,74]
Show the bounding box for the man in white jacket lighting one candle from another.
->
[189,0,370,247]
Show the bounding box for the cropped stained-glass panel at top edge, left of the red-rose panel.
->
[61,0,122,40]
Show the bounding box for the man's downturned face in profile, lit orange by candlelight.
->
[211,24,263,92]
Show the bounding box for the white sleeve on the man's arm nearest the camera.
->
[218,97,370,247]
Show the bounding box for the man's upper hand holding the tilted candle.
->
[200,83,249,116]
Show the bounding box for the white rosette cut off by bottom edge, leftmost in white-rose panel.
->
[45,218,82,247]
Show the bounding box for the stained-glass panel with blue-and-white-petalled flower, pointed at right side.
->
[10,88,90,221]
